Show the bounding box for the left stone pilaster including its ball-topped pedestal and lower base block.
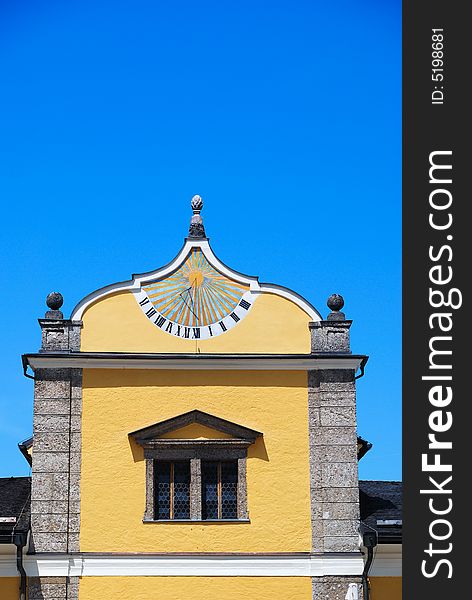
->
[28,295,82,600]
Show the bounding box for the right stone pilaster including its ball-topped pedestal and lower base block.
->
[308,296,361,600]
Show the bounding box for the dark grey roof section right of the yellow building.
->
[359,481,403,544]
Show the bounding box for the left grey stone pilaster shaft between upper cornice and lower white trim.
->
[31,369,82,552]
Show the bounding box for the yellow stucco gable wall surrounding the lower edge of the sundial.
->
[81,292,311,353]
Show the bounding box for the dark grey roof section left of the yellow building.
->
[0,477,31,544]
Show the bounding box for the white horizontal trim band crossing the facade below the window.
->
[0,553,364,577]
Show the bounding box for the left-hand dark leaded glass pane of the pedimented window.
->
[155,461,190,519]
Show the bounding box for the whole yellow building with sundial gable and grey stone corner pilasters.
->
[0,196,401,600]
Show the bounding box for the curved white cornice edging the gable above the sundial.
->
[70,238,321,321]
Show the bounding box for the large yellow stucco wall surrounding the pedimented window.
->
[80,369,311,552]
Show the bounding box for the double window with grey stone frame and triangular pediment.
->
[130,410,261,522]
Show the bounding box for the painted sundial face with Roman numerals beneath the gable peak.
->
[136,247,254,340]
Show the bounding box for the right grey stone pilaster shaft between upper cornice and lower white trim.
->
[308,369,359,552]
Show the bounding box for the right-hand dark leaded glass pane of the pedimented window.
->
[202,461,238,519]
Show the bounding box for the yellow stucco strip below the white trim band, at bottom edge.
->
[79,577,311,600]
